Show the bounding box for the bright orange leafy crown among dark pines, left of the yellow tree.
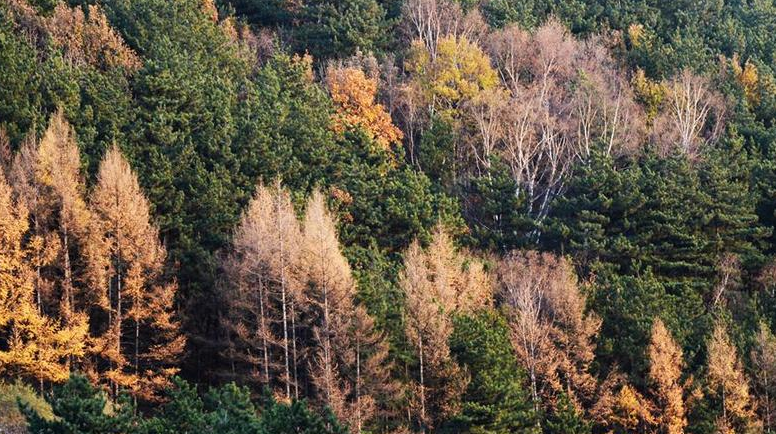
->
[326,66,402,150]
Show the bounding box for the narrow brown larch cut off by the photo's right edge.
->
[751,321,776,432]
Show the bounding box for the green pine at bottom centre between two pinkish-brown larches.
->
[442,311,537,434]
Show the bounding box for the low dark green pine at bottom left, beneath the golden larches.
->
[22,375,139,434]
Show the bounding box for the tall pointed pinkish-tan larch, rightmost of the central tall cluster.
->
[300,191,398,433]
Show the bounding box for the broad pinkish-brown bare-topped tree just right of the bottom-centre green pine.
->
[499,251,601,420]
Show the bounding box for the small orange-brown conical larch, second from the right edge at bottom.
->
[707,321,761,433]
